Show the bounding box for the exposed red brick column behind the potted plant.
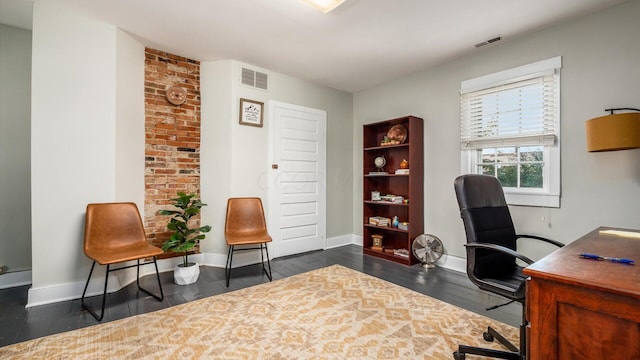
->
[144,48,200,253]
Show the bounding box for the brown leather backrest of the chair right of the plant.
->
[224,197,267,236]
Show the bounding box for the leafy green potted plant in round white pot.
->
[158,191,211,285]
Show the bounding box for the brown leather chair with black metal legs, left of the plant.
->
[81,203,164,321]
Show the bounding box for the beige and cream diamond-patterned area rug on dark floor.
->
[0,265,518,359]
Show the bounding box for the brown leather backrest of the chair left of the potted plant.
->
[84,203,147,253]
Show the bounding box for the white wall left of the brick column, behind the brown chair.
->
[29,2,144,305]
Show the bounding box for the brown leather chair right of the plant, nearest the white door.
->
[224,197,272,287]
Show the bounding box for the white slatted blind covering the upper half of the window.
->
[460,69,560,150]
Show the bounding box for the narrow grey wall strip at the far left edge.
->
[0,24,31,272]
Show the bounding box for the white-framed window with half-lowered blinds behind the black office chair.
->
[460,57,561,207]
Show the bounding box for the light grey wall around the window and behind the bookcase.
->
[353,1,640,258]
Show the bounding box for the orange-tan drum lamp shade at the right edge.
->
[586,112,640,152]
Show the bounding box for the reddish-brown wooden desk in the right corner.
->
[524,227,640,360]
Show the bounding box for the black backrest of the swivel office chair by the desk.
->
[454,174,516,279]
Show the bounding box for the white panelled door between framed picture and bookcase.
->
[269,101,327,257]
